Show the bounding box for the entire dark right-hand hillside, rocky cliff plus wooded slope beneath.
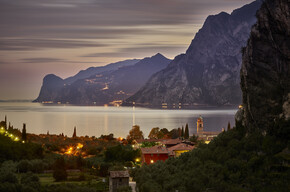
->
[134,0,290,192]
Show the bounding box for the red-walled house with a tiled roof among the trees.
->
[141,145,170,164]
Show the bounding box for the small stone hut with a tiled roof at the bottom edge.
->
[109,171,129,192]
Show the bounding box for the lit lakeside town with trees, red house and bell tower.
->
[0,116,231,191]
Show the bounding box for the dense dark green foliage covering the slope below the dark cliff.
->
[134,122,290,192]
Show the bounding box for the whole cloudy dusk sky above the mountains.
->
[0,0,253,100]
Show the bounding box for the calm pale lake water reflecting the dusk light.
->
[0,103,237,137]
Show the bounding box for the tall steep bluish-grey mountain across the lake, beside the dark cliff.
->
[126,0,261,106]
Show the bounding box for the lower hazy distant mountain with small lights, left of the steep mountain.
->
[36,53,171,105]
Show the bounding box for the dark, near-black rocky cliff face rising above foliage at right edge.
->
[237,0,290,132]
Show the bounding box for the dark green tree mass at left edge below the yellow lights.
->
[0,134,43,162]
